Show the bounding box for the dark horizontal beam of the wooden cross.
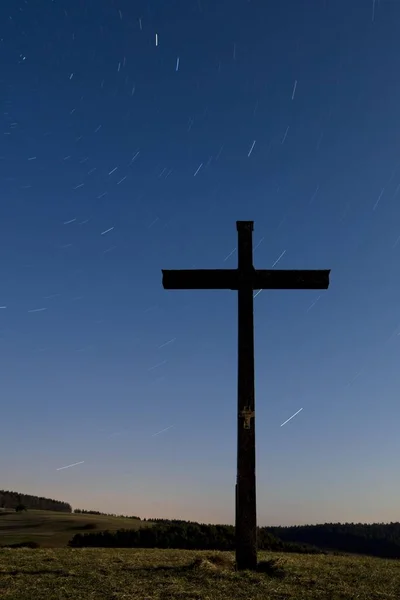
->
[162,269,330,290]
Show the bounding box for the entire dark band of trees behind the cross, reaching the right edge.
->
[69,519,400,558]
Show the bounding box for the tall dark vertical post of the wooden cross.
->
[235,221,257,570]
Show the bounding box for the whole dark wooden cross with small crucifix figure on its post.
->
[162,221,330,570]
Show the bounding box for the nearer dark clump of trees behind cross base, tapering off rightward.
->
[68,521,320,553]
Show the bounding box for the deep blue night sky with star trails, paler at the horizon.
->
[0,0,400,524]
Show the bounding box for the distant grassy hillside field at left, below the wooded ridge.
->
[0,510,146,548]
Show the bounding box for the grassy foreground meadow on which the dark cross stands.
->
[0,548,400,600]
